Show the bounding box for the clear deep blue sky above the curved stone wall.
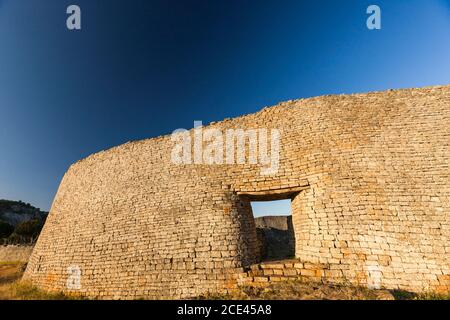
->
[0,0,450,213]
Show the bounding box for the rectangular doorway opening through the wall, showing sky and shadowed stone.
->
[251,198,295,261]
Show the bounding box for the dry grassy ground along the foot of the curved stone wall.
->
[0,262,450,300]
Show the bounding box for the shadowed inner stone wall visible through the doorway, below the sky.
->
[255,215,295,261]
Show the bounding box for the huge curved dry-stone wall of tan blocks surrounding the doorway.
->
[24,86,450,299]
